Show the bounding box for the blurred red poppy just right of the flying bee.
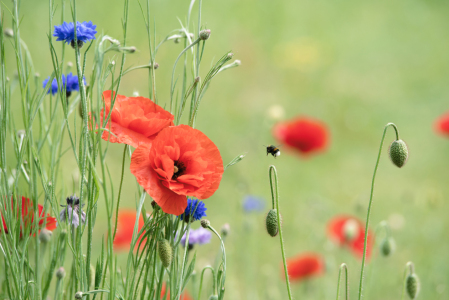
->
[273,117,329,155]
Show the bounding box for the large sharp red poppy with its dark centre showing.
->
[130,125,223,215]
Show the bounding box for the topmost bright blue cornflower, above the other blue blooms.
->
[53,21,97,48]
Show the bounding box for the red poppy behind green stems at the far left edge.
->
[0,196,57,237]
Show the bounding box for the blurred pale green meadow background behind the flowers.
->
[5,0,449,299]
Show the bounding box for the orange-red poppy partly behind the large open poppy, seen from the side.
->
[101,91,174,148]
